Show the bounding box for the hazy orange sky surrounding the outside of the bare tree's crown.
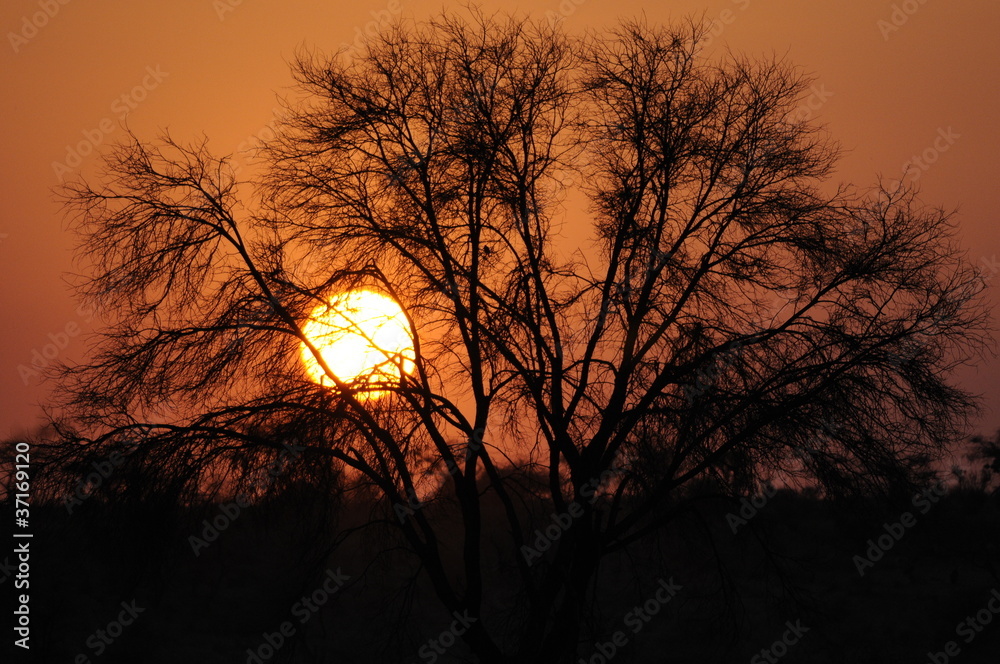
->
[0,0,1000,436]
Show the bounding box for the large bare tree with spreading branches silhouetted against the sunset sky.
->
[56,12,986,662]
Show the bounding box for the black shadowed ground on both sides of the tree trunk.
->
[0,480,1000,664]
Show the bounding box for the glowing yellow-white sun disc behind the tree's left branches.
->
[299,289,415,398]
